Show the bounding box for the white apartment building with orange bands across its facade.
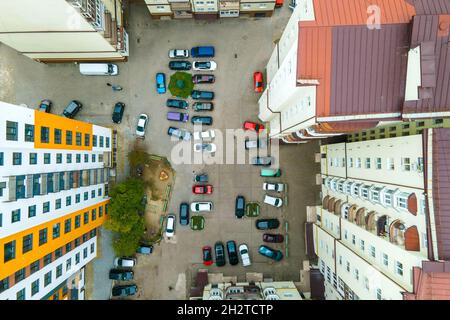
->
[0,102,113,300]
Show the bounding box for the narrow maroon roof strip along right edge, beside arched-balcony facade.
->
[432,128,450,260]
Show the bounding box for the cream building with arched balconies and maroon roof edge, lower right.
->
[313,129,450,300]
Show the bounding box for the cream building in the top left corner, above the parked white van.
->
[0,0,129,62]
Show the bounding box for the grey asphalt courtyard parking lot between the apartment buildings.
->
[0,5,319,299]
